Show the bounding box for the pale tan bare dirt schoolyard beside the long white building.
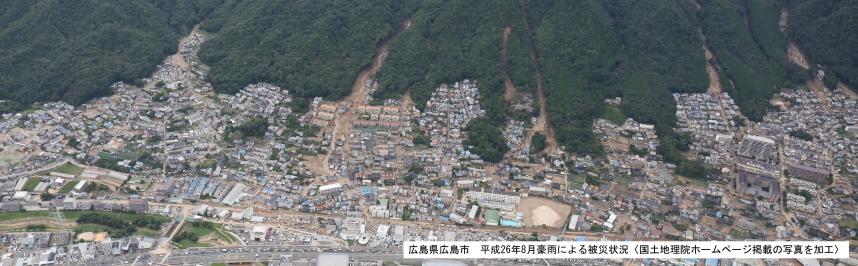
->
[516,197,572,228]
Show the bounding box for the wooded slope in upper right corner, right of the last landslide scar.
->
[788,0,858,90]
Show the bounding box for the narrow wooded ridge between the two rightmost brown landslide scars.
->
[700,0,786,120]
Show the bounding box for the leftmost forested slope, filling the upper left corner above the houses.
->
[0,0,219,111]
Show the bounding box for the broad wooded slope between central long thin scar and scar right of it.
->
[528,1,707,155]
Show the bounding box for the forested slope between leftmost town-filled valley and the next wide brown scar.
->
[200,0,415,98]
